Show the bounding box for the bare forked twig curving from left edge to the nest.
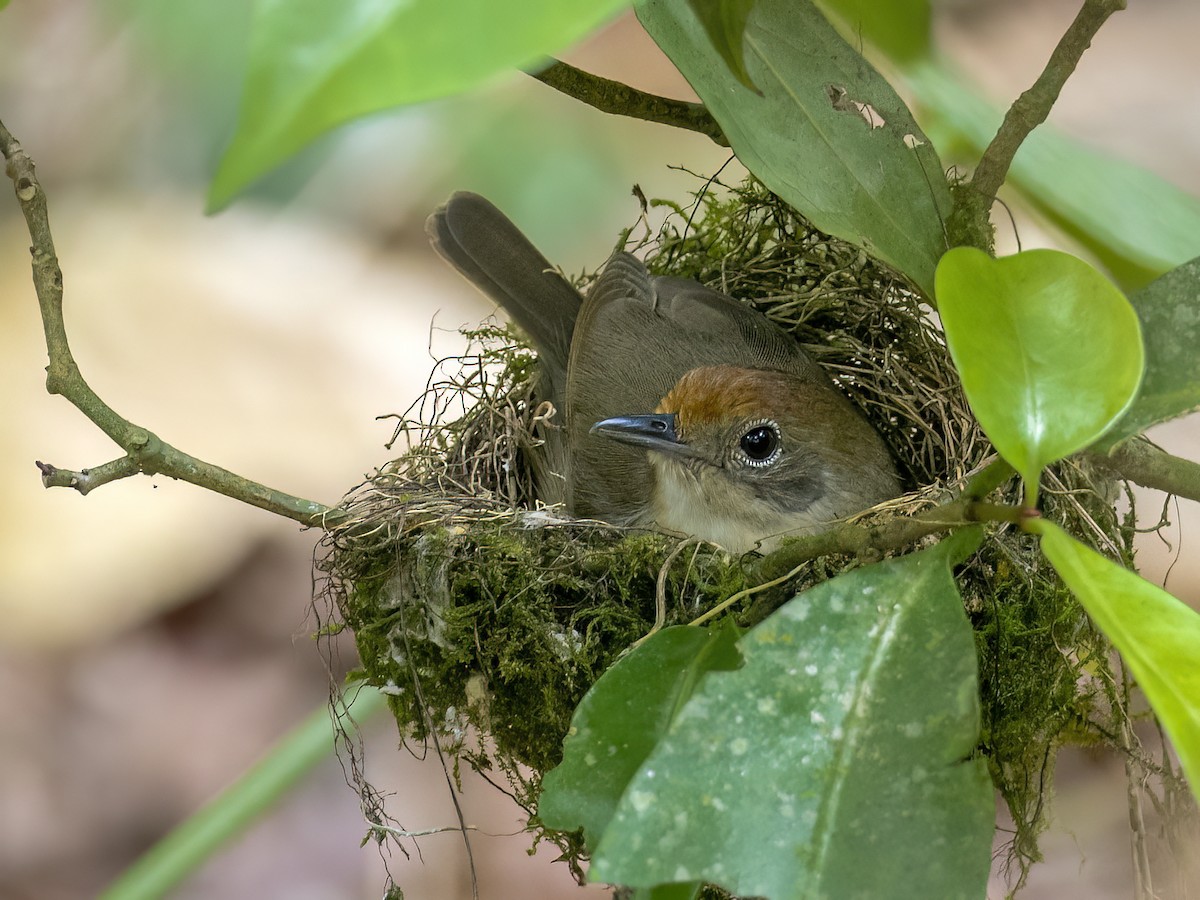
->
[0,122,344,527]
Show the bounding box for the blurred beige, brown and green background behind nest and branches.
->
[0,0,1200,900]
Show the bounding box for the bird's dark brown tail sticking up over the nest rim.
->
[425,191,582,384]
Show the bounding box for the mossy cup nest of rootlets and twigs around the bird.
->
[319,174,1190,888]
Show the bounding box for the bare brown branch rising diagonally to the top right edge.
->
[949,0,1126,250]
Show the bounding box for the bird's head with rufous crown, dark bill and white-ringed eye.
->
[592,366,899,551]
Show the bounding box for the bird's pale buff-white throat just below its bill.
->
[647,451,836,553]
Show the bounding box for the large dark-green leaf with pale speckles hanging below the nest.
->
[590,533,995,900]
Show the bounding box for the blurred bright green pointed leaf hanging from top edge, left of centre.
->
[209,0,628,209]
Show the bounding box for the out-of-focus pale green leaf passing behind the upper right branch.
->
[905,64,1200,288]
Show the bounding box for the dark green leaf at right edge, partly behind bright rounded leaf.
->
[1106,257,1200,443]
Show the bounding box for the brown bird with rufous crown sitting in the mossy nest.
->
[426,192,901,553]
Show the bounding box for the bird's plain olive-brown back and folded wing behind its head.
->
[566,253,830,523]
